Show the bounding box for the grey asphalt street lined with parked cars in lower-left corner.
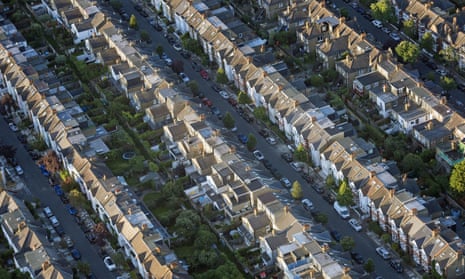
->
[0,120,115,278]
